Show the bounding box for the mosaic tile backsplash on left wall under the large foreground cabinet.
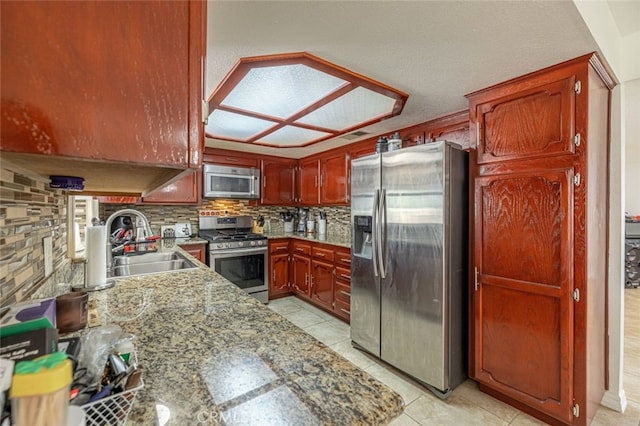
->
[0,163,72,307]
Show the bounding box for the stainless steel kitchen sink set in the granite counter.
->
[111,251,197,277]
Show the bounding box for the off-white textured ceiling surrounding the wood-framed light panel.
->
[205,0,598,158]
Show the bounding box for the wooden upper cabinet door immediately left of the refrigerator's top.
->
[320,151,351,205]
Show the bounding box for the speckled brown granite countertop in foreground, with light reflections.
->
[83,246,403,425]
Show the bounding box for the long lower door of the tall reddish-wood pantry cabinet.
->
[472,169,574,421]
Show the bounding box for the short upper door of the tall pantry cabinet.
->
[474,76,576,164]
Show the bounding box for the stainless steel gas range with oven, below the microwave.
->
[198,215,269,303]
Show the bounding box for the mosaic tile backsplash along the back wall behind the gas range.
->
[100,200,351,235]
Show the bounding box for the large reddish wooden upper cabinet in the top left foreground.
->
[0,1,206,168]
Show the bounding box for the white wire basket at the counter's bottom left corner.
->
[82,378,144,426]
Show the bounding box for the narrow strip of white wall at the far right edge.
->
[624,78,640,216]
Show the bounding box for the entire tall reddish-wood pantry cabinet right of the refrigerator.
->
[467,54,615,424]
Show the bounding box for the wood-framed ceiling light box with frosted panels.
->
[205,52,409,148]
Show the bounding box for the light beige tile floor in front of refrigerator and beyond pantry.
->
[268,289,640,426]
